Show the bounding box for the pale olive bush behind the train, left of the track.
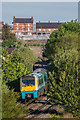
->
[16,40,38,72]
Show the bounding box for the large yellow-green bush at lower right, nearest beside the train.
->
[47,49,80,116]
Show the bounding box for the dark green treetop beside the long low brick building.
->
[43,20,80,59]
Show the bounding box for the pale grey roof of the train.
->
[23,68,46,77]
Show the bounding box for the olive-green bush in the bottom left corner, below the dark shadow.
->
[2,84,28,119]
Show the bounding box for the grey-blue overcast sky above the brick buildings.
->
[2,2,78,24]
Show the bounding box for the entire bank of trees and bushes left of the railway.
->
[2,24,38,118]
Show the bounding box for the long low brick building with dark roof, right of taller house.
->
[36,21,62,35]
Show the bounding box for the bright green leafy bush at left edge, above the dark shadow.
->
[2,47,28,83]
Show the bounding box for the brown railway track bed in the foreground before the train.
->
[25,96,64,120]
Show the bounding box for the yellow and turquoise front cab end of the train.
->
[20,77,38,99]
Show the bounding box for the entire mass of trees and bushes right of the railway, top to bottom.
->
[44,21,80,117]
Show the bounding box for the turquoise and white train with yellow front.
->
[20,68,48,99]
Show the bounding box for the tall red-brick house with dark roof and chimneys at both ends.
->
[13,16,33,35]
